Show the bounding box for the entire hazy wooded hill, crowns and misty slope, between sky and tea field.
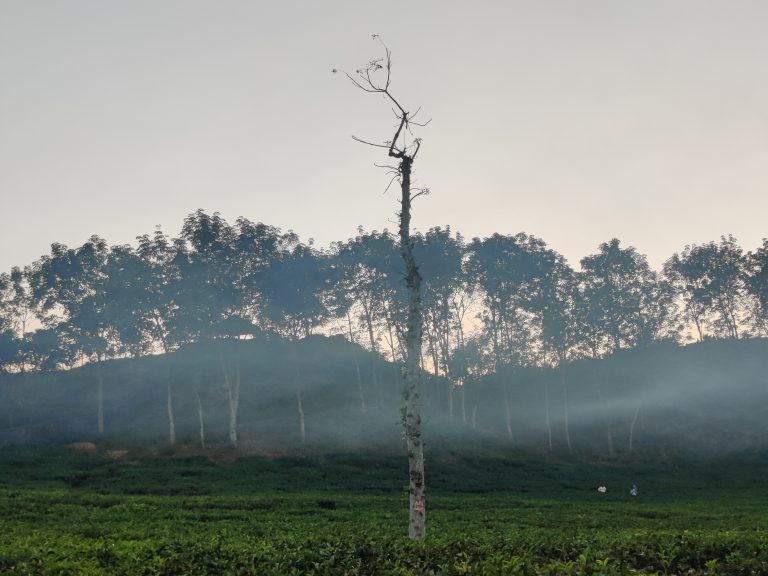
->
[0,210,768,455]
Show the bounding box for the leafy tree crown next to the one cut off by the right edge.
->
[664,235,748,341]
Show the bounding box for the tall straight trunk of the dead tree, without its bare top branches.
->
[400,156,426,539]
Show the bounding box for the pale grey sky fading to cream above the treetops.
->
[0,0,768,272]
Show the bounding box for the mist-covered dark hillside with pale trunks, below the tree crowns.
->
[0,335,768,457]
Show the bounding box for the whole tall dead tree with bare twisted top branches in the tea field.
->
[333,39,429,539]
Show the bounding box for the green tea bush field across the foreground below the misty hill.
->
[0,448,768,576]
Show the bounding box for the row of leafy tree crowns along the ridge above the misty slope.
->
[0,210,768,374]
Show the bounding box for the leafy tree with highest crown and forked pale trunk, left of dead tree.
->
[170,209,298,445]
